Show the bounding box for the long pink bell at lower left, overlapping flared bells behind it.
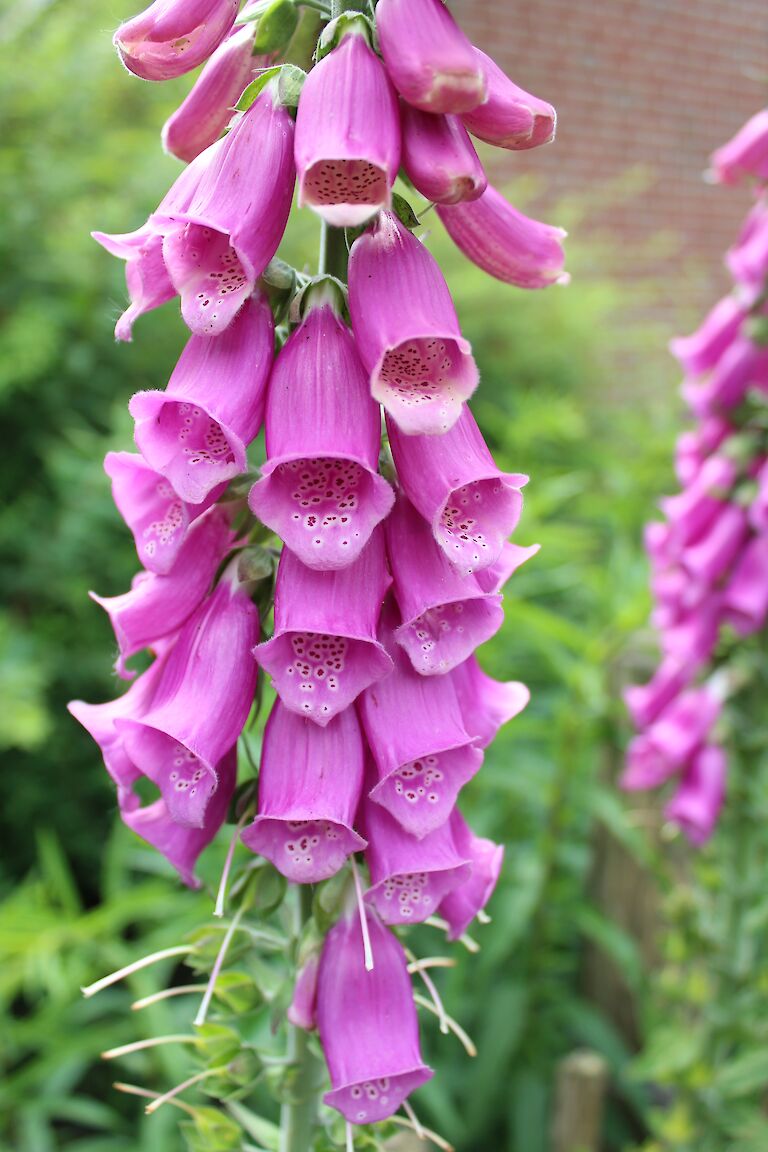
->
[116,561,259,827]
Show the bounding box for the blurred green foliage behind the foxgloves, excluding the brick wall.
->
[0,0,768,1152]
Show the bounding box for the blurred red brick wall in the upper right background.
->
[450,0,768,301]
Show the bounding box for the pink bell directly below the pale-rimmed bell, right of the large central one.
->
[387,408,527,575]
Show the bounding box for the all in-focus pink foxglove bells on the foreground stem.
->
[70,0,565,1123]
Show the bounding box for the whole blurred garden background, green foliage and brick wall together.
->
[0,0,768,1152]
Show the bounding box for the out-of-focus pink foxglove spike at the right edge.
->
[622,109,768,844]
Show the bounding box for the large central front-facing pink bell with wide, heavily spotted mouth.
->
[249,281,394,570]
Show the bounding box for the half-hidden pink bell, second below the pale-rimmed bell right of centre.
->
[386,494,504,676]
